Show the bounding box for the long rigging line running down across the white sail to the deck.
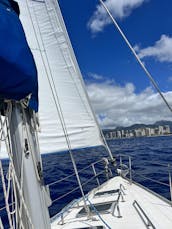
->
[26,0,89,215]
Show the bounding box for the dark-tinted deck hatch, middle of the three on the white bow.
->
[77,202,112,217]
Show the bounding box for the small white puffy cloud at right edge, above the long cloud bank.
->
[135,35,172,62]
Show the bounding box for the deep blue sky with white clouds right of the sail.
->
[59,0,172,127]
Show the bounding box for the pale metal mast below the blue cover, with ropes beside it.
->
[9,103,50,229]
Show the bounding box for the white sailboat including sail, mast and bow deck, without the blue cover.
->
[0,0,172,229]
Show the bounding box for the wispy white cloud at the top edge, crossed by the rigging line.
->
[88,0,147,33]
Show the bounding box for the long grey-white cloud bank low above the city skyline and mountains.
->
[87,82,172,128]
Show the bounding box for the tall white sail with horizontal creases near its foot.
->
[18,0,103,152]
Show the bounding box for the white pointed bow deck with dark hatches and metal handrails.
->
[51,176,172,229]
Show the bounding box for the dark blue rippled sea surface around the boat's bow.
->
[0,136,172,228]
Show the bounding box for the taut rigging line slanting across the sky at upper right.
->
[99,0,172,112]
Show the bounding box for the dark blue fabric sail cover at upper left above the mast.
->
[0,0,38,112]
